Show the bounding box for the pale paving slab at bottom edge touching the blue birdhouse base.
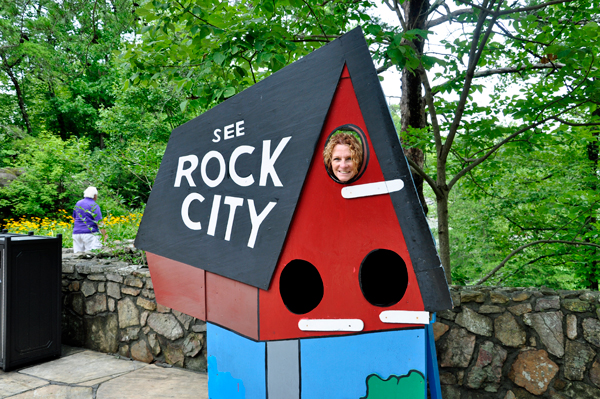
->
[96,365,208,399]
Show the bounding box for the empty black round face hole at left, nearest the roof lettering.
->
[279,259,323,314]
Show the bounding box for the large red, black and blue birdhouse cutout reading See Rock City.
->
[136,29,452,399]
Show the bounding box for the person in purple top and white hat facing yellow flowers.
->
[73,187,106,253]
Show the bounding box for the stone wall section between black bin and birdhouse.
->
[62,250,206,371]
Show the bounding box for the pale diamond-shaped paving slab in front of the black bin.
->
[19,350,148,384]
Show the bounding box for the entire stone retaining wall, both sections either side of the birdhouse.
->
[63,252,600,399]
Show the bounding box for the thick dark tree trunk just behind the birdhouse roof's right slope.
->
[400,0,429,215]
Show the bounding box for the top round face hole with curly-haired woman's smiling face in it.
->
[323,125,369,184]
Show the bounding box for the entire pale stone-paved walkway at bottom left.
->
[0,346,208,399]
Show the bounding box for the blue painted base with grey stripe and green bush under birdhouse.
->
[207,323,427,399]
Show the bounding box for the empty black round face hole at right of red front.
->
[358,249,408,307]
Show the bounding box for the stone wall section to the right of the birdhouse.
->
[434,286,600,399]
